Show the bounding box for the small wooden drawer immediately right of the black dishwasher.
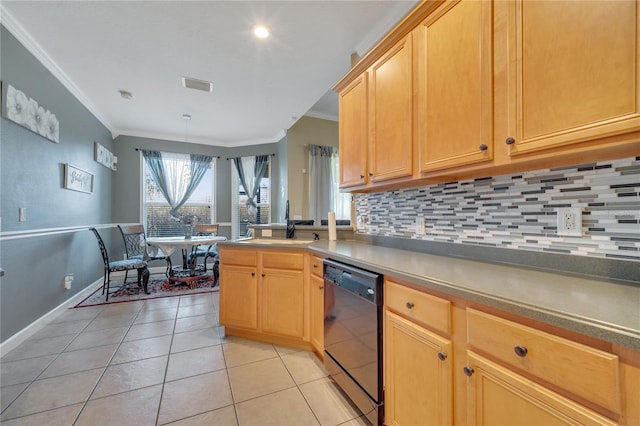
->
[384,280,451,334]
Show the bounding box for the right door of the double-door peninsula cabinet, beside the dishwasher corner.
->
[260,268,305,339]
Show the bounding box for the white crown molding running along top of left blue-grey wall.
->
[0,3,118,139]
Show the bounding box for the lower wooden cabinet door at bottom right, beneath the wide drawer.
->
[466,351,615,426]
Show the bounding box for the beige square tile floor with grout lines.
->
[0,282,367,426]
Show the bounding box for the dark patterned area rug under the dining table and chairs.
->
[74,275,218,308]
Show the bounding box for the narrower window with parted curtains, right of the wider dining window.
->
[231,160,271,238]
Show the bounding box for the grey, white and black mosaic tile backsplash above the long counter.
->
[356,157,640,262]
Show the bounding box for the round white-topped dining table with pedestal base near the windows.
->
[147,235,227,286]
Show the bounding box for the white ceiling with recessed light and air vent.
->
[0,0,417,146]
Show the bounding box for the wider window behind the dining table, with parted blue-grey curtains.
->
[142,153,215,237]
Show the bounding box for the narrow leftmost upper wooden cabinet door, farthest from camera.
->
[338,73,368,188]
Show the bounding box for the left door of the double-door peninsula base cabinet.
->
[220,265,258,330]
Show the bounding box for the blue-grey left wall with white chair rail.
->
[0,27,115,341]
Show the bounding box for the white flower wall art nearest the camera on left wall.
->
[2,83,60,143]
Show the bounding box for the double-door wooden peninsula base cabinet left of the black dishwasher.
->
[220,247,310,349]
